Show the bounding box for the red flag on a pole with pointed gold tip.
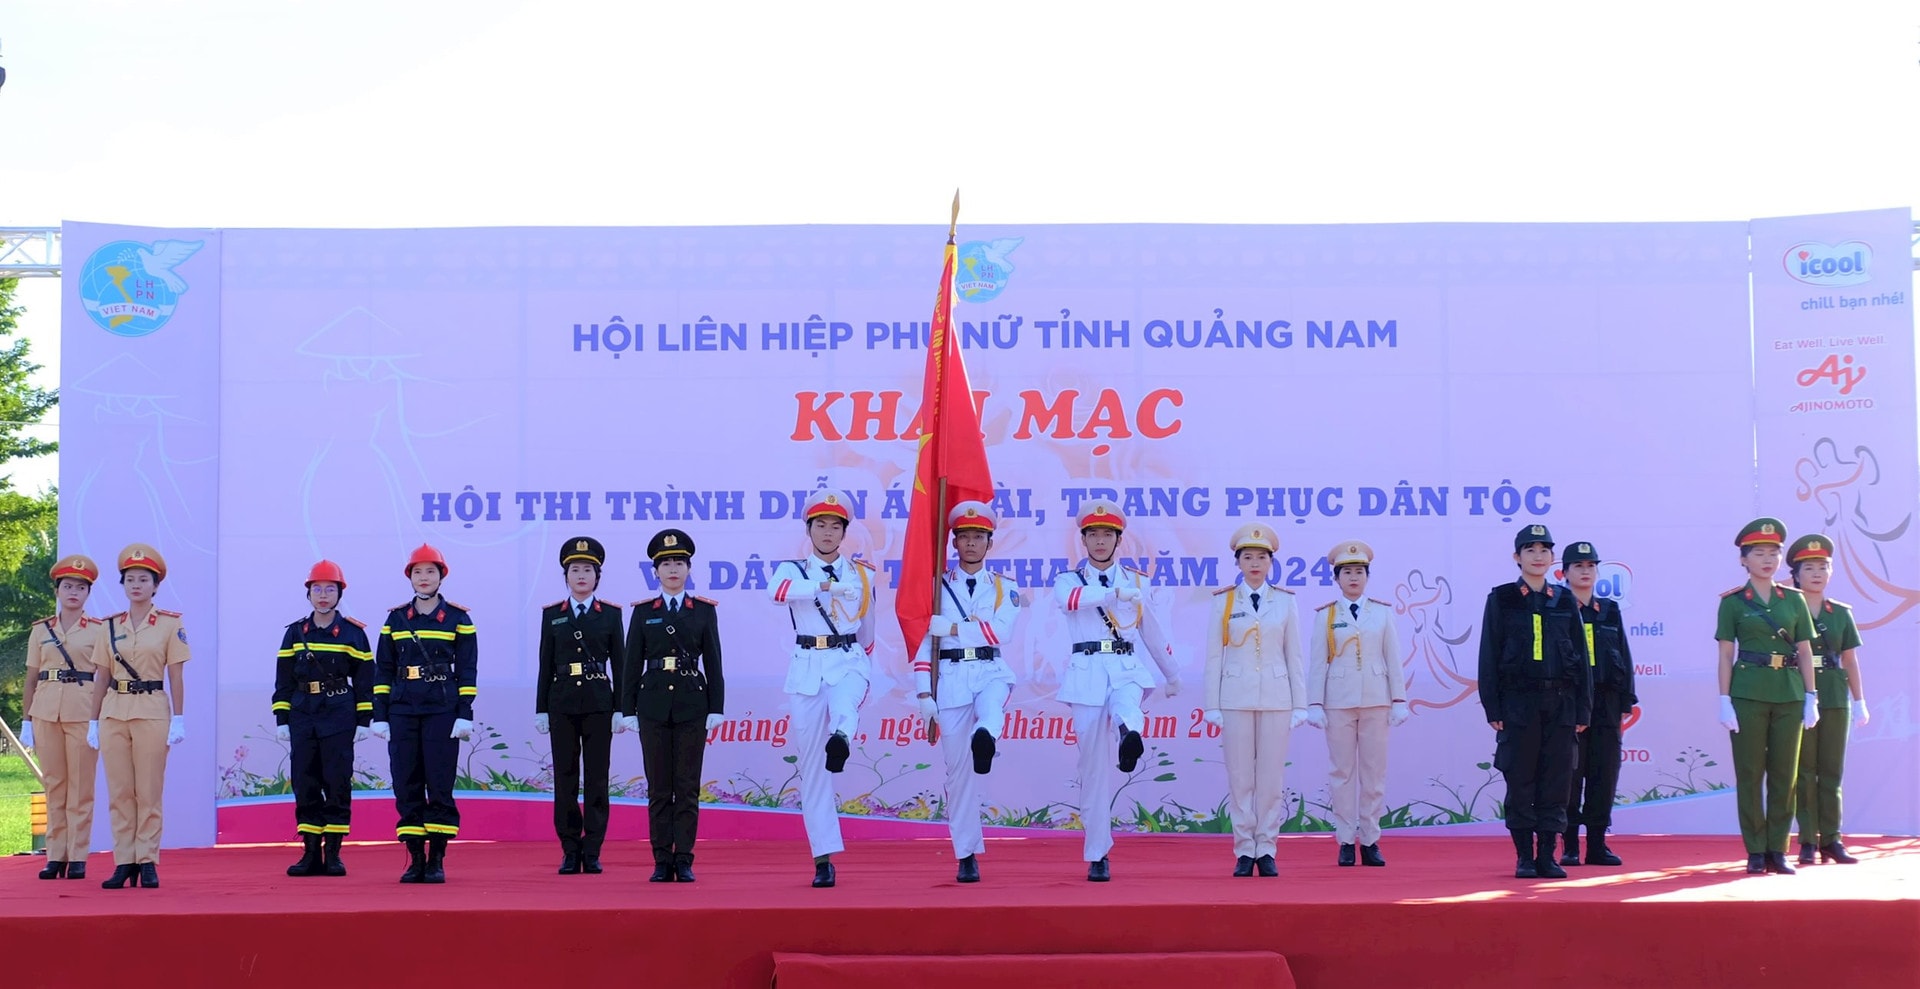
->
[893,192,993,672]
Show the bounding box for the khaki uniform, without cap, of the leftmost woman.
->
[27,616,106,862]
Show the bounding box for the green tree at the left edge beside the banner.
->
[0,278,60,724]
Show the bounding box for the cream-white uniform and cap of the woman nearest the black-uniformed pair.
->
[1306,542,1407,864]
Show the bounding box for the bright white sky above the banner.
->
[0,0,1920,490]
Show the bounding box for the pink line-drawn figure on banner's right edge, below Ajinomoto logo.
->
[1793,436,1920,632]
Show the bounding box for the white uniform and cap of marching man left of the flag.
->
[766,492,874,856]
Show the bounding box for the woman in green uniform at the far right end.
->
[1788,536,1866,866]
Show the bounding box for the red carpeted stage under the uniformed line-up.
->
[0,835,1920,989]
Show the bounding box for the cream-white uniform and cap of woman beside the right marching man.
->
[1206,524,1308,872]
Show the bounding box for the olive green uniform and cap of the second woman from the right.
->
[1713,519,1812,868]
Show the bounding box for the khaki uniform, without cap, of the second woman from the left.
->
[94,609,190,866]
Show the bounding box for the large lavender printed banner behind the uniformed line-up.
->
[61,211,1920,845]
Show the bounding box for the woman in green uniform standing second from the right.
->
[1713,519,1820,876]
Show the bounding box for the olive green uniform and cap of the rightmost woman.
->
[1788,536,1860,864]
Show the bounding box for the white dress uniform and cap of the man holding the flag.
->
[914,501,1020,858]
